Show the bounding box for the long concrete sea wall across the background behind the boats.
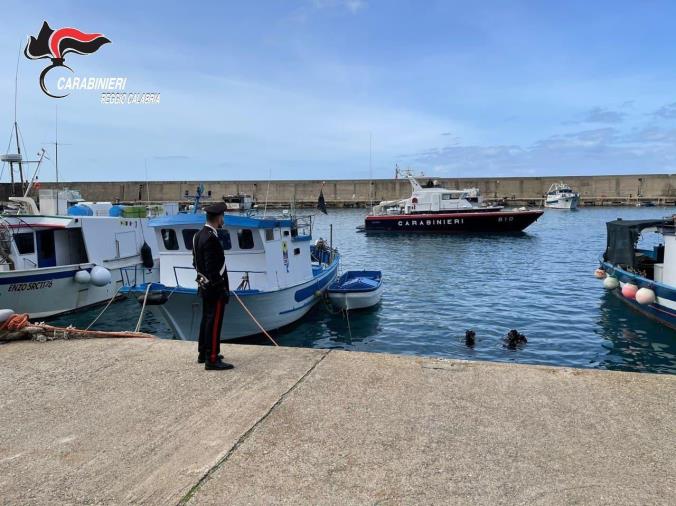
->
[0,174,676,206]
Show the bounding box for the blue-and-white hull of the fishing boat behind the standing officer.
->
[149,262,338,341]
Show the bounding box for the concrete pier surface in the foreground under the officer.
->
[0,339,676,504]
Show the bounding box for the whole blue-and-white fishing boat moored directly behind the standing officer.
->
[121,213,339,341]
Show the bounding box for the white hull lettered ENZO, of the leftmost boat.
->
[0,262,159,319]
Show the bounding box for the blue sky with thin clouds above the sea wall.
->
[0,0,676,181]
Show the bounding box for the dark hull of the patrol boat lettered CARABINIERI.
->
[364,209,543,233]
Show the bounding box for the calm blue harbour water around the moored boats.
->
[54,208,676,374]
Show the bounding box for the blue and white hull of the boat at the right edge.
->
[601,262,676,330]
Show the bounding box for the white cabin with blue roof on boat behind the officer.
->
[150,214,313,291]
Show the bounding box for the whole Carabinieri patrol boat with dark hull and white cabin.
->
[357,173,543,233]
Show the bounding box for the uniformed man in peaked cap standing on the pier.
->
[193,202,233,370]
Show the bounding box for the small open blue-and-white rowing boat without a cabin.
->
[326,271,383,309]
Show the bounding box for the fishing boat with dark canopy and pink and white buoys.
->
[595,218,676,329]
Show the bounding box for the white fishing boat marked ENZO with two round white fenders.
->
[0,197,158,318]
